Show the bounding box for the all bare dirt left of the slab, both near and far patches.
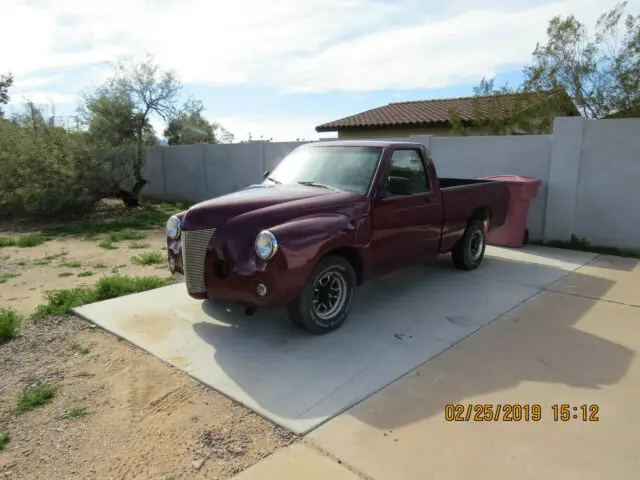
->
[0,212,295,480]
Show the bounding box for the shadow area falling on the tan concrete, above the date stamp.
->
[350,273,640,430]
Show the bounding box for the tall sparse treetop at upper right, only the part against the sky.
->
[524,1,640,118]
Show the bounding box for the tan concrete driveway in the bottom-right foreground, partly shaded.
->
[308,288,640,480]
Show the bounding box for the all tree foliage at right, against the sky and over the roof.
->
[449,2,640,135]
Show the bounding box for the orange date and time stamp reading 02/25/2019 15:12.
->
[444,403,600,422]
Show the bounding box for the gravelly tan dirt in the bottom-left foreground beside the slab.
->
[0,316,294,480]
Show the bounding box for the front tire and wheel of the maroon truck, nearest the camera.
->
[287,255,356,335]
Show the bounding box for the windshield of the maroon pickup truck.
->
[265,145,382,193]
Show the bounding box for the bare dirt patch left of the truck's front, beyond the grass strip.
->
[0,229,169,315]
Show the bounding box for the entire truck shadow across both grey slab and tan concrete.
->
[193,251,635,428]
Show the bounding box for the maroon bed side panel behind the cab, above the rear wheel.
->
[438,178,509,253]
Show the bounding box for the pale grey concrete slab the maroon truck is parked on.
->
[76,249,588,434]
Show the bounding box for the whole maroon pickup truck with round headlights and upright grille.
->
[167,141,509,334]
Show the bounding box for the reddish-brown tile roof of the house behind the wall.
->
[316,91,568,132]
